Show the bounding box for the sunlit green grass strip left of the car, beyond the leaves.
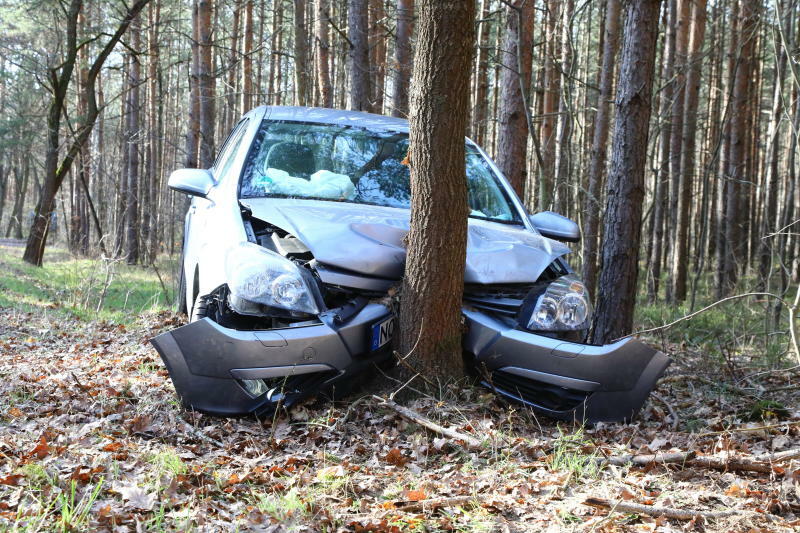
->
[0,242,177,324]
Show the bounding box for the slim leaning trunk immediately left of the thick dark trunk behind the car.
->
[583,0,620,295]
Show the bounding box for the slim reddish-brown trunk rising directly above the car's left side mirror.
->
[197,0,216,168]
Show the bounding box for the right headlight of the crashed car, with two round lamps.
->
[527,276,591,331]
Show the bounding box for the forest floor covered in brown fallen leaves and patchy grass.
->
[0,243,800,532]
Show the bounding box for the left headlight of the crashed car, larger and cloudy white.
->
[225,242,319,315]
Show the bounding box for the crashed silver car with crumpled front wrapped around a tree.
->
[152,107,670,422]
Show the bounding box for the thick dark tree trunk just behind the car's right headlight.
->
[593,0,661,342]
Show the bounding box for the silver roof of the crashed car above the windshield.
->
[247,106,408,133]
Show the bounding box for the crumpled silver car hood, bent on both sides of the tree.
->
[243,198,570,284]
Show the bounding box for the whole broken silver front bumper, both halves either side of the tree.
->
[151,303,671,422]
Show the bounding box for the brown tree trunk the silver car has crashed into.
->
[400,0,475,382]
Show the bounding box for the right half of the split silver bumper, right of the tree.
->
[464,309,672,422]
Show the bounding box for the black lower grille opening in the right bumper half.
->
[483,370,591,411]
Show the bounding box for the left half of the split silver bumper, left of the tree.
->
[151,304,390,416]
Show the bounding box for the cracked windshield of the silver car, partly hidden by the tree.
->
[240,121,520,224]
